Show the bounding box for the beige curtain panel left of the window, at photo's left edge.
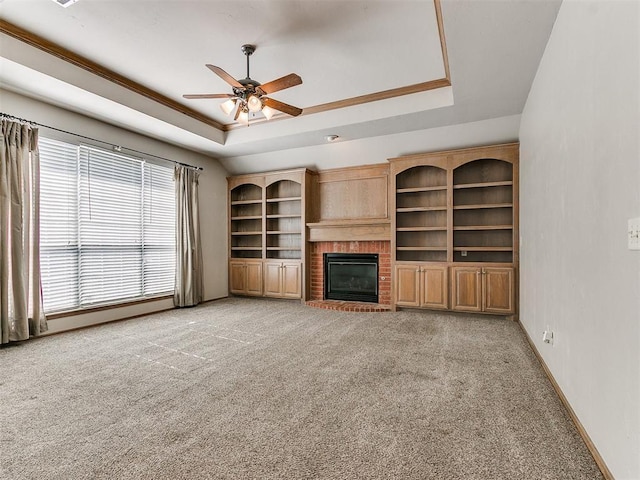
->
[0,119,47,343]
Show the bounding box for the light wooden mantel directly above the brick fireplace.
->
[307,218,391,242]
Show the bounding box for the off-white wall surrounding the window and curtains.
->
[0,90,228,332]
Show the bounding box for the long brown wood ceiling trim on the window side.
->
[0,20,223,130]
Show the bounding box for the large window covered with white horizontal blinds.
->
[39,138,175,313]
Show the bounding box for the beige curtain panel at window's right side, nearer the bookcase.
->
[173,165,202,307]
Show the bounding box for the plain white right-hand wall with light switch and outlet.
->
[520,0,640,480]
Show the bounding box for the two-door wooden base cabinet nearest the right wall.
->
[451,266,514,314]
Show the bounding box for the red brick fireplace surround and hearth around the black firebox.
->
[307,241,391,312]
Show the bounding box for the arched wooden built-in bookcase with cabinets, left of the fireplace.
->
[227,169,315,299]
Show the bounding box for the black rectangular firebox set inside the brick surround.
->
[324,253,378,303]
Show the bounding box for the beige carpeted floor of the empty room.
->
[0,298,602,480]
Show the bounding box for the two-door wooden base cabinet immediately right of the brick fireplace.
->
[395,264,449,309]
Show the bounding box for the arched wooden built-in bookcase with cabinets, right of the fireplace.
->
[389,144,518,314]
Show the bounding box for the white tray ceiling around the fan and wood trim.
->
[0,0,560,167]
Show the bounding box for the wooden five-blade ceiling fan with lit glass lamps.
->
[183,45,302,125]
